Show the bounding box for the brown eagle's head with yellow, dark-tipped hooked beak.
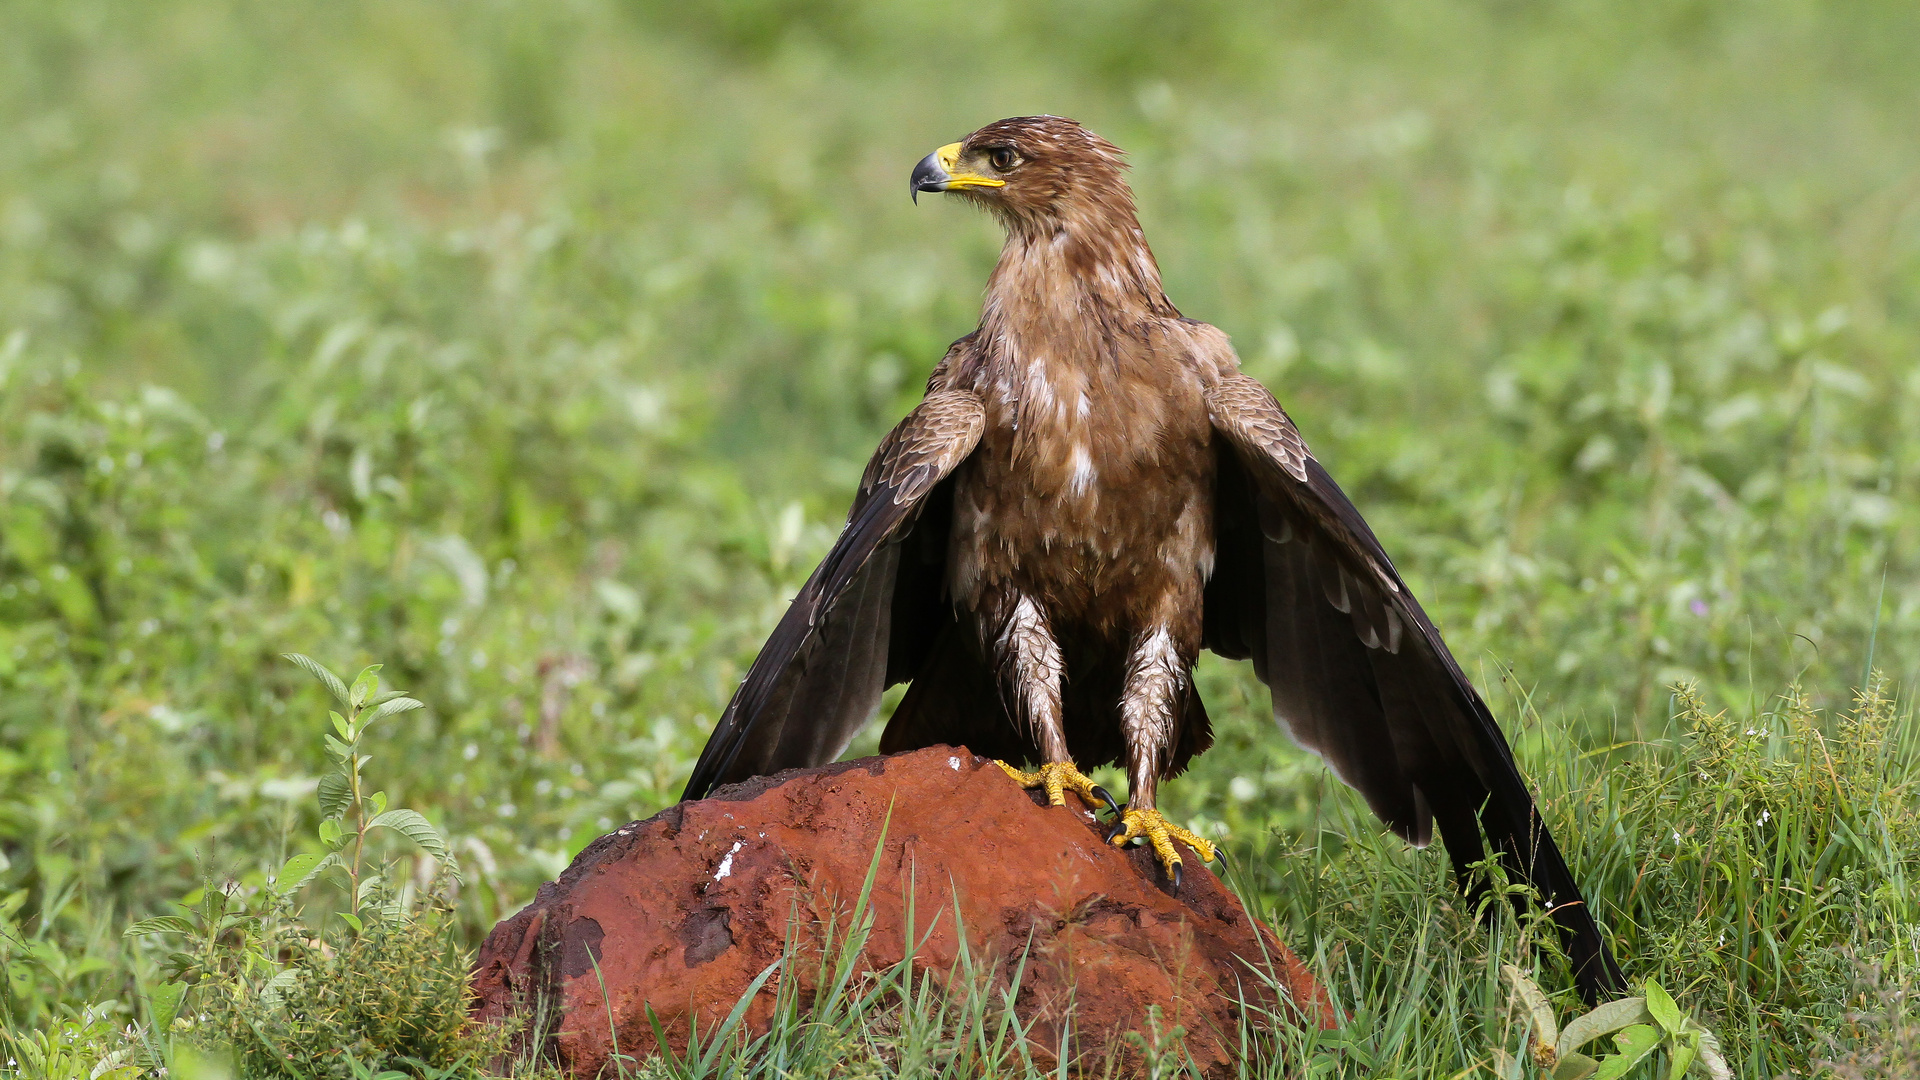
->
[912,115,1133,233]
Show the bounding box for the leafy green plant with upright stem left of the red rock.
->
[108,653,507,1080]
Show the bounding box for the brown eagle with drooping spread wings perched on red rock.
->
[684,115,1624,1001]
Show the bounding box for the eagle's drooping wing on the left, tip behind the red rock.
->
[682,390,987,799]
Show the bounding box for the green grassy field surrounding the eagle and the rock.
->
[0,0,1920,1080]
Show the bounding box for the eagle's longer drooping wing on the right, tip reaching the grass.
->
[1206,373,1624,1001]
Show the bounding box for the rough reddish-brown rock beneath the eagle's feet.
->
[474,748,1332,1076]
